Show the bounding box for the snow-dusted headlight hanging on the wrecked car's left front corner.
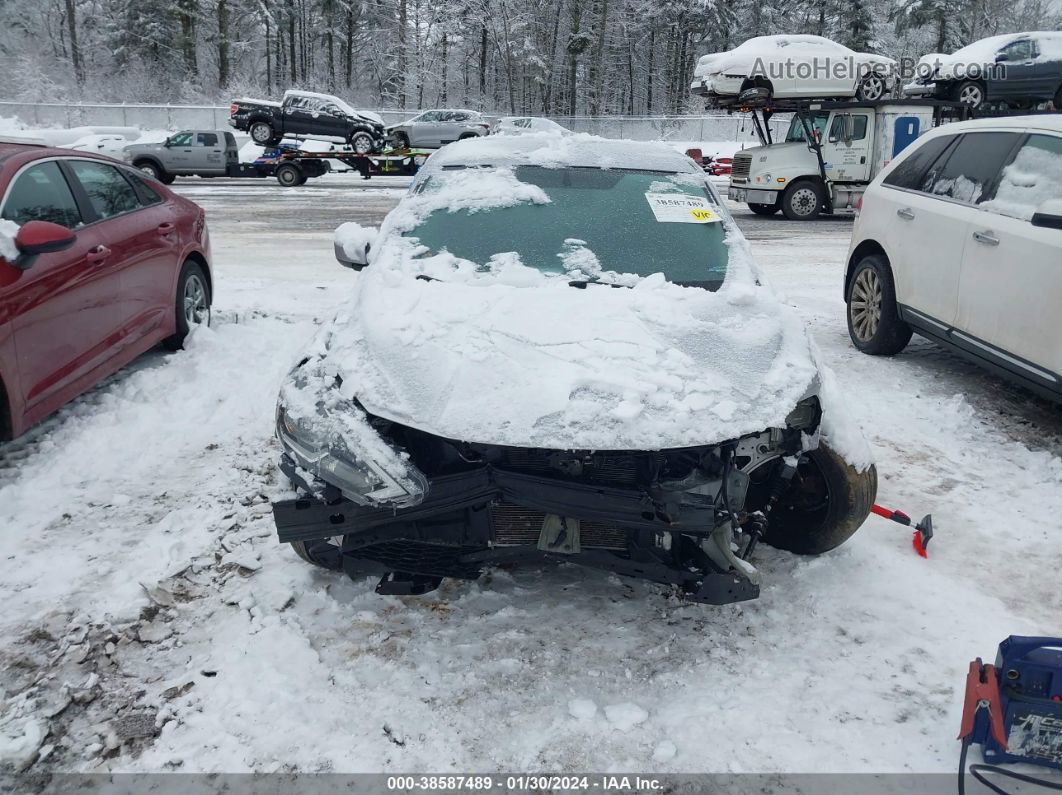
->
[276,405,428,507]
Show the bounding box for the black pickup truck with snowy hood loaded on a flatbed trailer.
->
[228,91,387,155]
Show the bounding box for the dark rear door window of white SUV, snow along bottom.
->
[922,133,1021,204]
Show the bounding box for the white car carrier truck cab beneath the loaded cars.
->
[727,100,961,221]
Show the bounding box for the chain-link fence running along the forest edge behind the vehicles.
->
[0,101,788,143]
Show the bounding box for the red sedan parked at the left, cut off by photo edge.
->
[0,139,212,439]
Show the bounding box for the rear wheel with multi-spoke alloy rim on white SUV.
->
[845,254,911,356]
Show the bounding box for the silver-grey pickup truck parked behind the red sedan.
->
[122,129,240,185]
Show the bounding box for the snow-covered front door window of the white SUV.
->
[981,135,1062,221]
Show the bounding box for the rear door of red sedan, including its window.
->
[69,159,179,348]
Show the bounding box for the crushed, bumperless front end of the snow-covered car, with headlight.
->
[267,377,821,605]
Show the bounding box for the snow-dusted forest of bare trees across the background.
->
[0,0,1062,116]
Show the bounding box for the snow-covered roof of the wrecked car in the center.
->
[425,133,700,172]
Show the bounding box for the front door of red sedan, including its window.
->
[0,159,119,424]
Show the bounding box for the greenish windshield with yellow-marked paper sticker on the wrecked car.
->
[408,166,729,290]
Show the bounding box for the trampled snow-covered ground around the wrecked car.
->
[0,175,1062,773]
